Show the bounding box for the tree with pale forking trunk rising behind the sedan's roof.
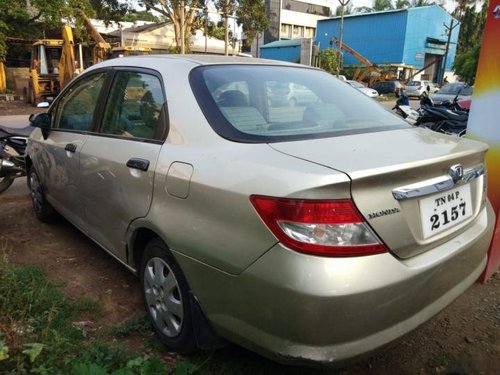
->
[140,0,206,53]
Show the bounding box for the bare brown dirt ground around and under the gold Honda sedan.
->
[0,102,500,375]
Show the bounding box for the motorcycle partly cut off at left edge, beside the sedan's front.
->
[0,125,34,193]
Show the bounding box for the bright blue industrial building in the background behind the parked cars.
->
[316,5,460,80]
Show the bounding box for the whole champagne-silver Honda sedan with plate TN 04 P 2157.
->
[26,55,494,365]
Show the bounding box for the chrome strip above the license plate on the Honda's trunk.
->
[392,164,486,201]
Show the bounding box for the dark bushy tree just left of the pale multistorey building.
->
[236,0,269,53]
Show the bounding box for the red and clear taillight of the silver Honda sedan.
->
[250,195,387,257]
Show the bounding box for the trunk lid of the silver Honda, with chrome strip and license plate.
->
[270,129,487,258]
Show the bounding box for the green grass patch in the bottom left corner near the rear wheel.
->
[0,237,170,375]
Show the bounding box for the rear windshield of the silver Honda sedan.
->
[190,65,409,142]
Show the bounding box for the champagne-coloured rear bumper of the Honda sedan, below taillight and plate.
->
[179,205,494,365]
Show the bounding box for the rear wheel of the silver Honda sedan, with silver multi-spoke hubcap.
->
[140,238,197,354]
